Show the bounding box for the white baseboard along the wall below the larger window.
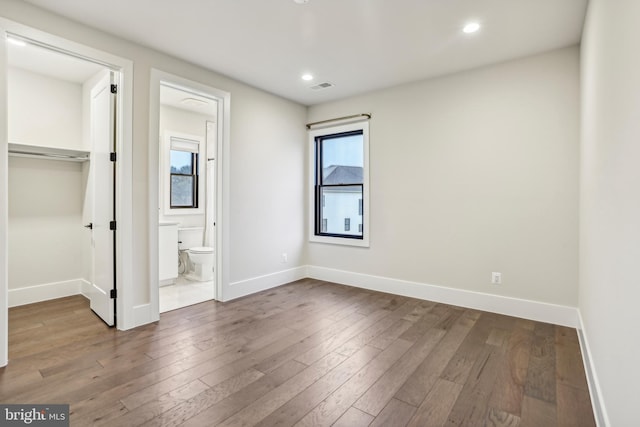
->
[307,266,579,328]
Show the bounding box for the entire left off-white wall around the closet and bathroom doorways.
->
[0,0,306,306]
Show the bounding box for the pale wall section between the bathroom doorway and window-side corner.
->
[230,92,306,286]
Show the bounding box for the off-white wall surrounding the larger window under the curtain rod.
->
[308,47,579,307]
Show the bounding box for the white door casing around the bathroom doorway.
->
[148,68,231,321]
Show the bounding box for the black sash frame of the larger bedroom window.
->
[314,129,364,240]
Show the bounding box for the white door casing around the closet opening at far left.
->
[0,17,137,367]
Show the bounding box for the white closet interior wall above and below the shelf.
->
[7,64,90,305]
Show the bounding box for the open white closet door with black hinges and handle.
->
[89,72,116,326]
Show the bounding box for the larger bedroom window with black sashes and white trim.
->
[309,122,369,246]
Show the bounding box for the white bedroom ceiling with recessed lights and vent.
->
[17,0,587,105]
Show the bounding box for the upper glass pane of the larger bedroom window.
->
[321,133,364,185]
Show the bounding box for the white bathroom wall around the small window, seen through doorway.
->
[158,105,215,227]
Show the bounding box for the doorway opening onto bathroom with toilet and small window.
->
[150,74,229,314]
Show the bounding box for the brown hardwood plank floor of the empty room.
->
[0,279,595,427]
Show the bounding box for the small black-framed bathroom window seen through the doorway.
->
[168,136,200,209]
